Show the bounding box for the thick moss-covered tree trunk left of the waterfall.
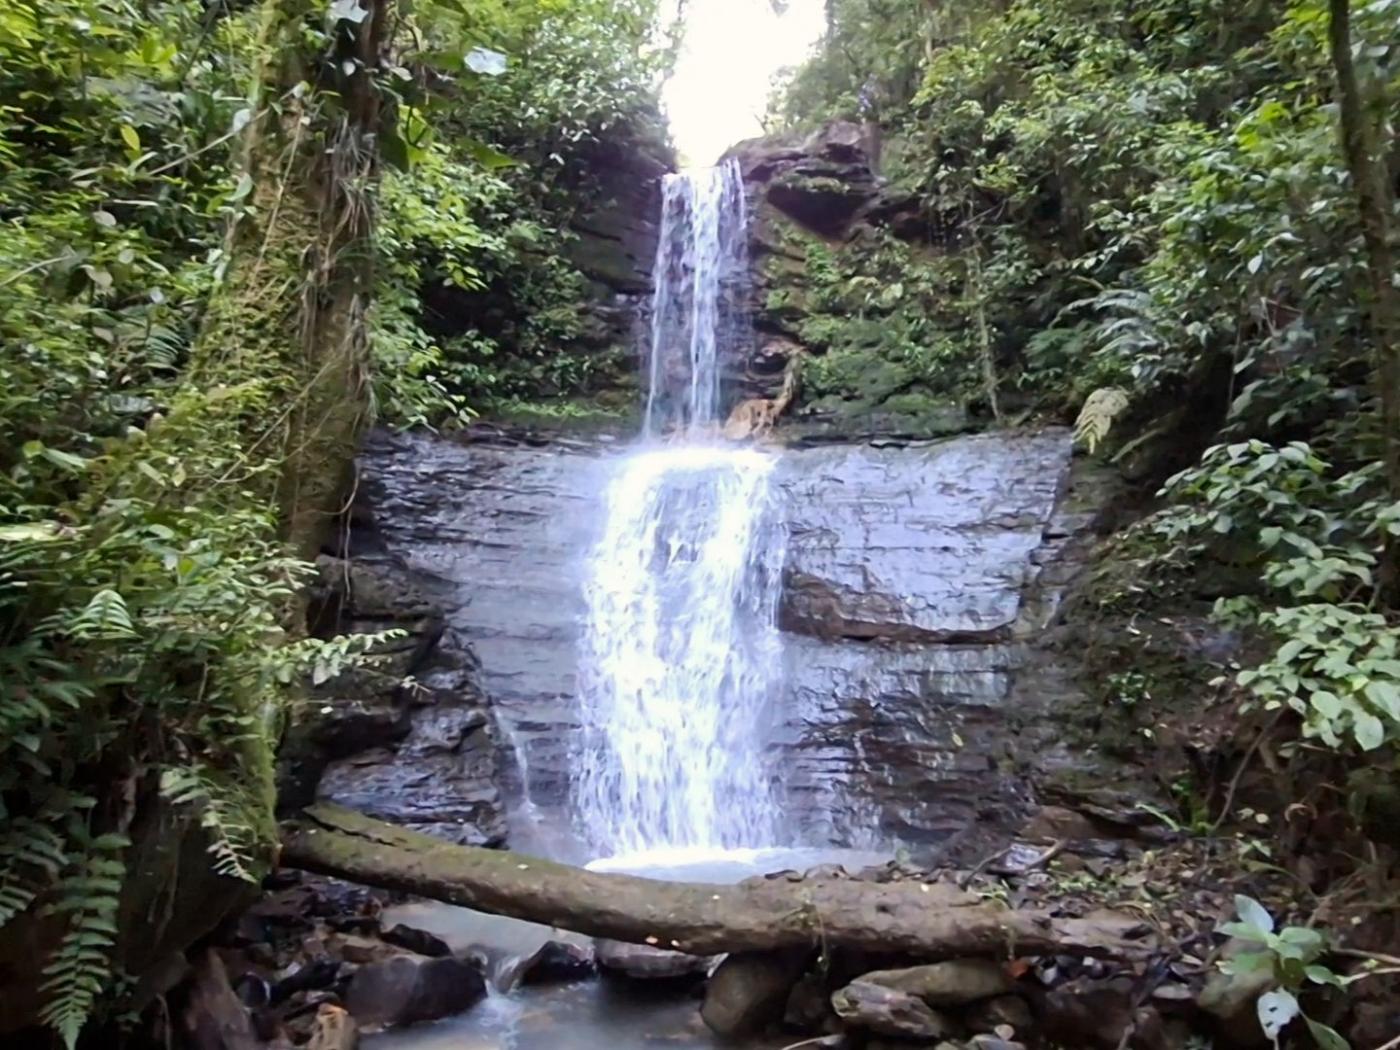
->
[190,0,389,559]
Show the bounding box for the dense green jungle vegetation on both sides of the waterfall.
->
[0,0,1400,1047]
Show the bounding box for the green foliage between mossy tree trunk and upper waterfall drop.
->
[372,0,671,426]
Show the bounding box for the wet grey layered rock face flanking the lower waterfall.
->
[347,430,1136,854]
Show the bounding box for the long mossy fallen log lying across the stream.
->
[281,805,1149,960]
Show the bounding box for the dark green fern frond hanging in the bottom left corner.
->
[39,836,127,1050]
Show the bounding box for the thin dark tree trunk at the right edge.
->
[1329,0,1400,579]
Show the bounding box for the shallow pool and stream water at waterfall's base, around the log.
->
[364,848,889,1050]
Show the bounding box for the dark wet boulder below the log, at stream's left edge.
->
[346,955,486,1028]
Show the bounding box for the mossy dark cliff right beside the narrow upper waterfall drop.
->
[727,122,979,440]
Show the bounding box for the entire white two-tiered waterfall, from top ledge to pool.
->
[575,161,784,853]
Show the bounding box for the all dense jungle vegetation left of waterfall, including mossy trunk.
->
[0,0,669,1046]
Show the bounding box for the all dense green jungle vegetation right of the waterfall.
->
[773,0,1400,1046]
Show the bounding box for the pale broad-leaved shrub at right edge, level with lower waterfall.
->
[1149,440,1400,750]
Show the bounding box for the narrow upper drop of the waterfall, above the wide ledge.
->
[643,160,749,437]
